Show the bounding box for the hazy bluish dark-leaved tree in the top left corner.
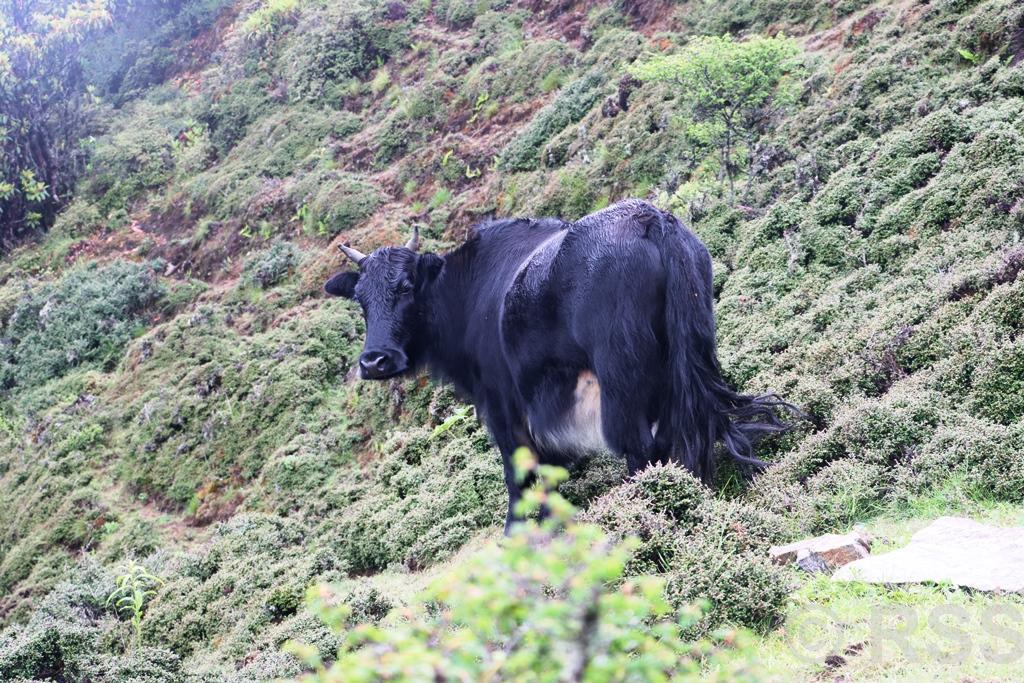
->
[0,0,232,245]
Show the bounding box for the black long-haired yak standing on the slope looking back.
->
[325,200,788,530]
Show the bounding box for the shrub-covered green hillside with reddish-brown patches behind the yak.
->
[0,0,1024,681]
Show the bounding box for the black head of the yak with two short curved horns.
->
[324,228,444,380]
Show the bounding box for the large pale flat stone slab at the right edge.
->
[833,517,1024,593]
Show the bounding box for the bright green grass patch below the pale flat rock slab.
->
[757,578,1024,681]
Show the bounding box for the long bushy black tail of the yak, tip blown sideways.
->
[648,211,800,482]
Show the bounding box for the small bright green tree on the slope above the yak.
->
[633,35,800,197]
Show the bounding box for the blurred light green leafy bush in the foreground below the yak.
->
[288,452,757,683]
